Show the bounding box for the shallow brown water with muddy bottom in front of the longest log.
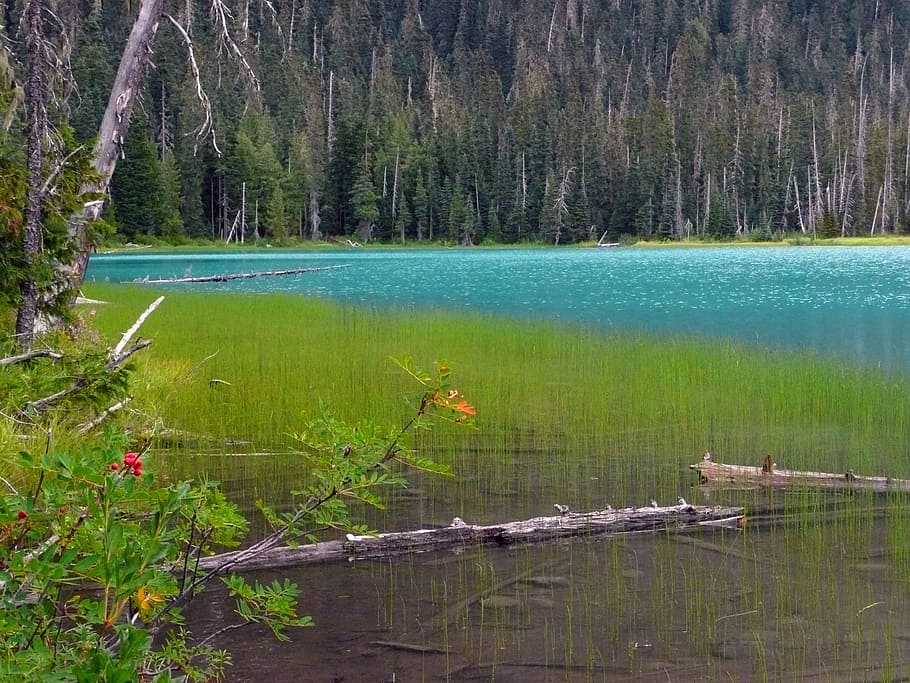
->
[189,494,910,683]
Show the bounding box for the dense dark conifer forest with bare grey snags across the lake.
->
[0,0,910,244]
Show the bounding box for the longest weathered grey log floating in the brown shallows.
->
[200,502,743,571]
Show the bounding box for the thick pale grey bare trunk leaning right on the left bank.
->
[33,0,166,334]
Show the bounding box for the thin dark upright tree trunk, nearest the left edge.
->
[16,0,47,351]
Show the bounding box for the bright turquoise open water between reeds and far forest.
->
[88,247,910,371]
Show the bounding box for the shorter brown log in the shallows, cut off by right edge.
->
[689,453,910,493]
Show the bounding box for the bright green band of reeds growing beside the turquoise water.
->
[76,285,910,520]
